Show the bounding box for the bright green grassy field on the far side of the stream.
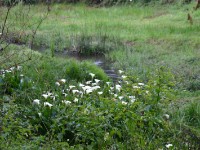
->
[7,3,200,91]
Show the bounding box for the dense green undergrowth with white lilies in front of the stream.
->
[0,49,175,149]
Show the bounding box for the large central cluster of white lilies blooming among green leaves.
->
[33,70,148,115]
